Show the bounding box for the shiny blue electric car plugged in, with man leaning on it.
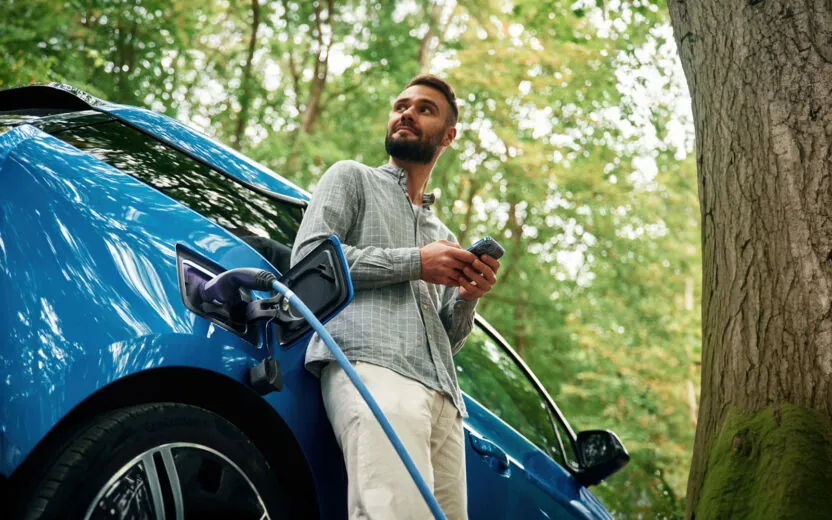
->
[0,85,629,519]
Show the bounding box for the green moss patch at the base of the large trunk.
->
[693,405,832,520]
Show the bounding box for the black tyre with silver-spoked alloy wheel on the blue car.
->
[15,403,291,520]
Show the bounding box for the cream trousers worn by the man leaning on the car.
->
[321,361,468,520]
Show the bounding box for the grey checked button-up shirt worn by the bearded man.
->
[292,161,477,417]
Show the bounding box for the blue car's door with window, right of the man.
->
[455,322,609,519]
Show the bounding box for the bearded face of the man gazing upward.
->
[384,85,453,164]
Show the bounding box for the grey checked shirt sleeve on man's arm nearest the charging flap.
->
[291,161,422,290]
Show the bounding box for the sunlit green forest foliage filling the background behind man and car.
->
[0,0,700,518]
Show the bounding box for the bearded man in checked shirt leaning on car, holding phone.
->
[292,75,500,519]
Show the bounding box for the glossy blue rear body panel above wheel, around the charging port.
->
[0,127,340,516]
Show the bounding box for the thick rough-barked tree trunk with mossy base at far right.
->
[669,0,832,520]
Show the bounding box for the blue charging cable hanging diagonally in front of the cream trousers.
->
[272,280,446,520]
